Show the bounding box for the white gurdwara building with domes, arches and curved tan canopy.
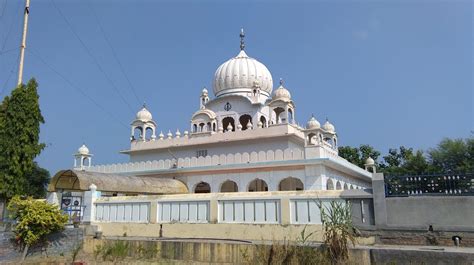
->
[51,29,372,198]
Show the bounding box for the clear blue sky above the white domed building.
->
[0,0,474,174]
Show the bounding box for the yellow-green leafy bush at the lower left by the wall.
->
[8,196,68,247]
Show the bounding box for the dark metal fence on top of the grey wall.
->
[385,174,474,197]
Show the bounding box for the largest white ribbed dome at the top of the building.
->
[213,50,273,97]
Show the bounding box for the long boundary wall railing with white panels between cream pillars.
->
[92,191,345,224]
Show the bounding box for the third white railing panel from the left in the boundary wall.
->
[218,199,281,224]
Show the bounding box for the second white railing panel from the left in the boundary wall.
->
[158,201,209,223]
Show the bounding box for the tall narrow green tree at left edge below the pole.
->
[0,79,45,199]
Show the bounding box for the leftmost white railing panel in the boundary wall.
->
[95,202,150,223]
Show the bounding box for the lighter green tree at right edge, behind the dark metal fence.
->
[428,136,474,173]
